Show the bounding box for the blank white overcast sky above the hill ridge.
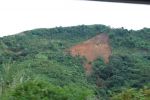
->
[0,0,150,37]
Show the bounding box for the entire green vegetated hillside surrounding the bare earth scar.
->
[0,25,150,100]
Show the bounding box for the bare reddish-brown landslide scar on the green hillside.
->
[70,33,111,74]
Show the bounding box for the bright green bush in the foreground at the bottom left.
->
[3,80,93,100]
